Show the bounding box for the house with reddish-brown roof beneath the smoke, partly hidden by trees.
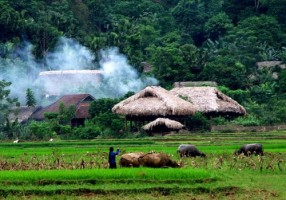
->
[31,94,95,126]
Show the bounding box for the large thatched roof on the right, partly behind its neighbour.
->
[170,87,246,115]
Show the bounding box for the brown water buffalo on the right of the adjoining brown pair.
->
[139,153,180,168]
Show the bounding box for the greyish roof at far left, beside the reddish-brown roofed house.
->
[8,106,41,123]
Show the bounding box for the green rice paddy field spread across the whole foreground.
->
[0,131,286,200]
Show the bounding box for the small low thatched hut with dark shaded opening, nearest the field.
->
[142,118,184,133]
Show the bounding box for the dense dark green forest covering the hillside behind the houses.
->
[0,0,286,141]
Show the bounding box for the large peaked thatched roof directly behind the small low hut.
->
[112,86,195,117]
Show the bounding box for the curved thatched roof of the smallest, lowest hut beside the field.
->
[143,118,184,131]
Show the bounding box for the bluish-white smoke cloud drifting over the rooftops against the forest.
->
[0,37,158,105]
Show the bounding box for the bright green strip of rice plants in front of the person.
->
[0,168,211,182]
